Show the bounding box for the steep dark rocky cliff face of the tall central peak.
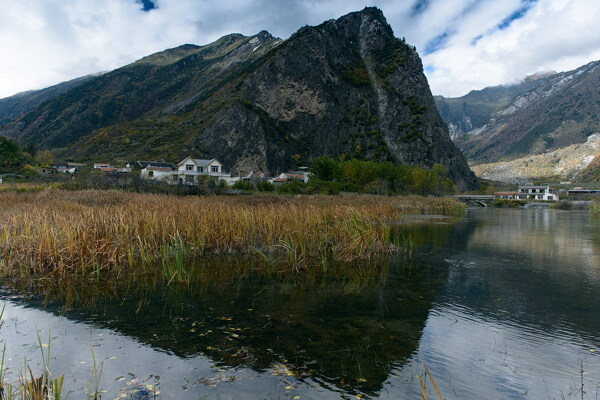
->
[207,8,475,187]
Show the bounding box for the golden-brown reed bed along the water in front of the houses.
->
[0,190,464,280]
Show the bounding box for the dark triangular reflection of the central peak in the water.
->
[1,262,446,393]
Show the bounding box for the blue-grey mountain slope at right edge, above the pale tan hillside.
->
[455,61,600,164]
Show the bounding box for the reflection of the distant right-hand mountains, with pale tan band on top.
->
[443,210,600,337]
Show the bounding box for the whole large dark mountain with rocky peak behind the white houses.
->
[0,8,478,189]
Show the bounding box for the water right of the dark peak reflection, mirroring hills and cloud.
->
[404,210,600,399]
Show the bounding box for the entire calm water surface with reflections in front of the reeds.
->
[0,209,600,399]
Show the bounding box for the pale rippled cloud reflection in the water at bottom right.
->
[406,304,600,399]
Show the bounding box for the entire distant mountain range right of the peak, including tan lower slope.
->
[436,61,600,182]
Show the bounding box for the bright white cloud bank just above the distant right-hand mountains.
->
[424,0,600,96]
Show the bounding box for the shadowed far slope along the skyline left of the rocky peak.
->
[0,32,278,151]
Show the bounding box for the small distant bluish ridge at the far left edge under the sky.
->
[0,75,97,125]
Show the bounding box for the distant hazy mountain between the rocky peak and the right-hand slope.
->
[434,71,556,140]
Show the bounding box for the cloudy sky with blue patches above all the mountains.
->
[0,0,600,98]
